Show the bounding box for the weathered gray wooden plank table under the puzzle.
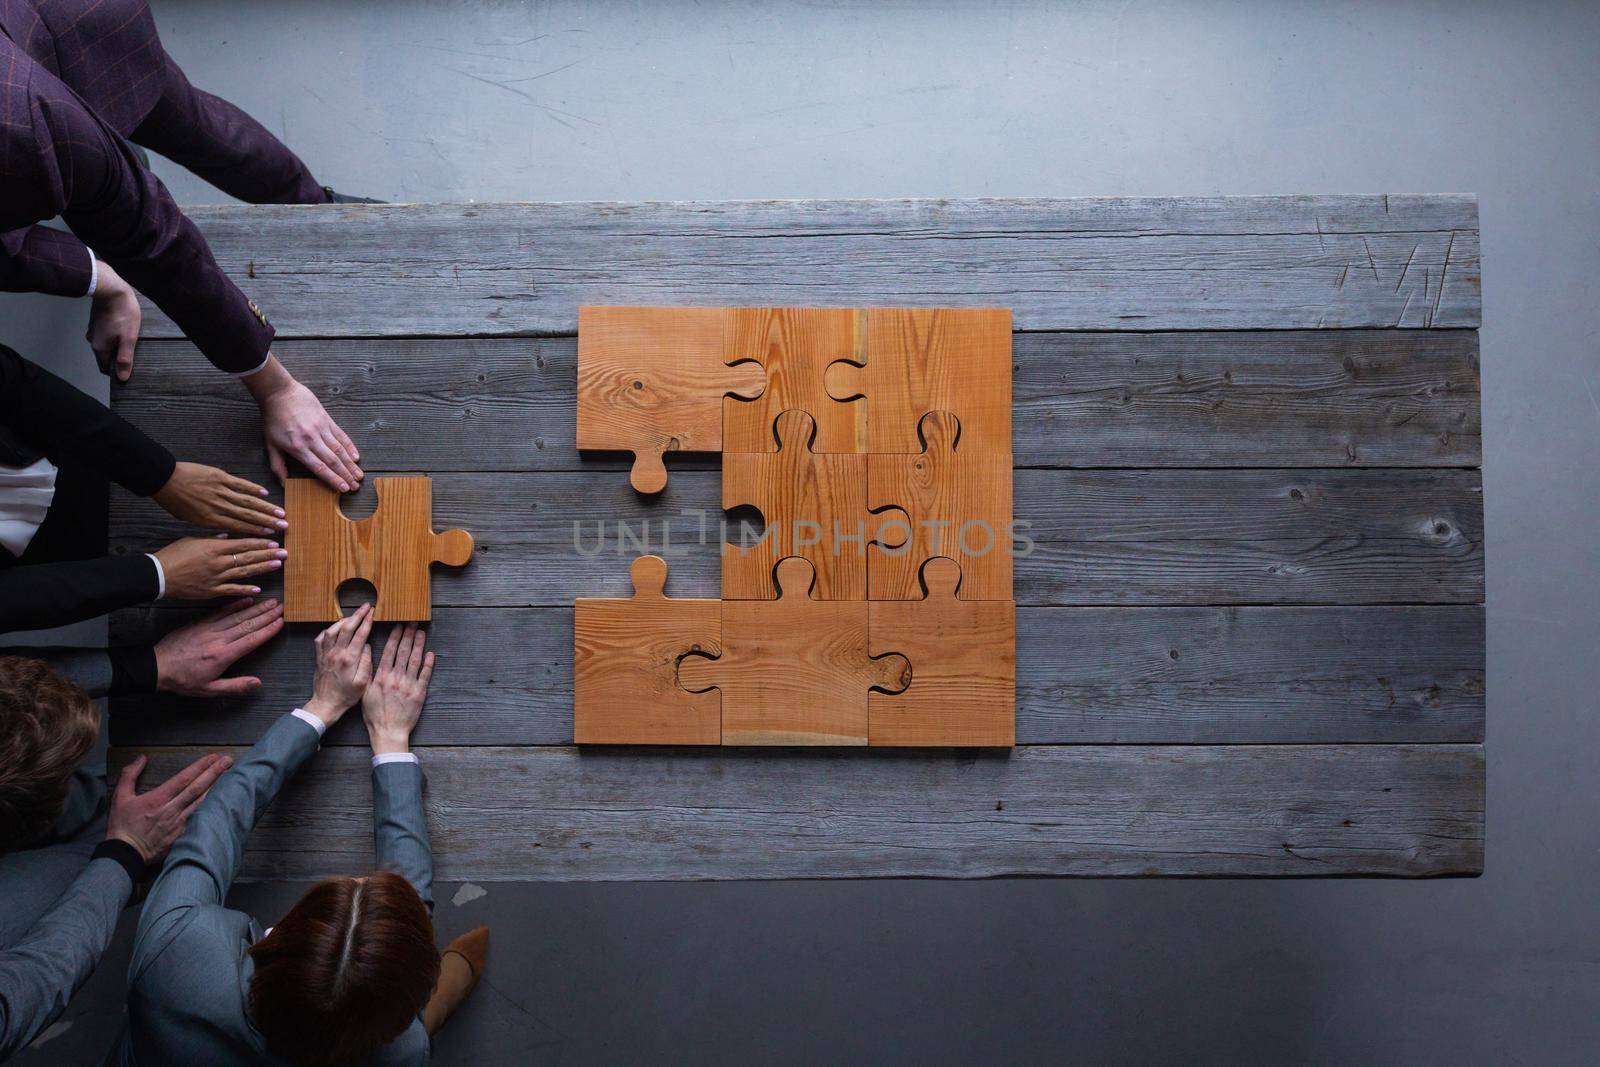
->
[112,197,1483,880]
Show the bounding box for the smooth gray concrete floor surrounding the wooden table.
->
[0,0,1600,1067]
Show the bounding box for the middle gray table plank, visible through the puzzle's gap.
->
[112,470,1483,606]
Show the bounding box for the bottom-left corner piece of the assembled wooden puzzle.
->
[573,555,722,745]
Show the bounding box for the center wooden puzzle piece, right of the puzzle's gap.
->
[722,411,915,600]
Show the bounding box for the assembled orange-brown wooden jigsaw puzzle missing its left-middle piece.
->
[573,307,1016,747]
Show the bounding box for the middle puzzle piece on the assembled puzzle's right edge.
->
[867,411,1011,600]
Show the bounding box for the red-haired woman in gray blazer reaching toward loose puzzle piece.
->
[109,605,488,1065]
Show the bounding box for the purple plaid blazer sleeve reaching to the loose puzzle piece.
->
[0,35,274,373]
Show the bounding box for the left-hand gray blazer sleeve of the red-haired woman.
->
[128,715,320,982]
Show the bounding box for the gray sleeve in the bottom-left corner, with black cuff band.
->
[0,859,133,1061]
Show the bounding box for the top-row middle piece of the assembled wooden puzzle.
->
[722,307,864,454]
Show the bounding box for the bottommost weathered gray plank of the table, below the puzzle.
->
[117,745,1483,881]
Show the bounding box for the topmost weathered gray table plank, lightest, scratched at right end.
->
[131,195,1480,338]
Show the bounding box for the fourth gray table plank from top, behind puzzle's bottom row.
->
[112,606,1483,745]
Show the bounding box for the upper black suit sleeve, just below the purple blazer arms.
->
[0,344,178,495]
